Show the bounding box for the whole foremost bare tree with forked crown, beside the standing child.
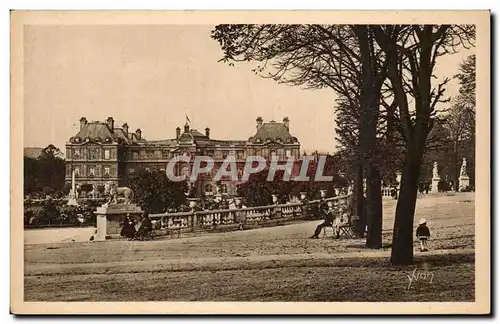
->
[374,25,475,264]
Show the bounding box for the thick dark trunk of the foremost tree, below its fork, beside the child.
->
[391,143,423,265]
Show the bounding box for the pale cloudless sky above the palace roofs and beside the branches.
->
[23,25,471,152]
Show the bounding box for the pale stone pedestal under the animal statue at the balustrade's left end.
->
[94,204,143,241]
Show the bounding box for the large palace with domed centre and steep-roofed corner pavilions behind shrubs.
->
[66,117,300,195]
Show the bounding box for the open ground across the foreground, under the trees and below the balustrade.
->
[25,194,475,301]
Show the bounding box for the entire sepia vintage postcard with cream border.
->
[11,11,491,315]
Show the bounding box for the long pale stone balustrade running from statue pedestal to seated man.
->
[149,195,350,232]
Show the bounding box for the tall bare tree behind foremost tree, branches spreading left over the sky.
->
[212,25,386,248]
